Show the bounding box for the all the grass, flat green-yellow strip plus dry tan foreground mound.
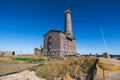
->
[0,56,96,80]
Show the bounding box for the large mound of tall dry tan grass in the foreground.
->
[30,57,95,80]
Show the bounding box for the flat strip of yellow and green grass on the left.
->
[0,56,45,64]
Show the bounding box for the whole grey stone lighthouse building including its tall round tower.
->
[43,9,76,57]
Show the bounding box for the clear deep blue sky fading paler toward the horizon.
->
[0,0,120,54]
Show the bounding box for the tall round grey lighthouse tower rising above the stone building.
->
[64,9,73,37]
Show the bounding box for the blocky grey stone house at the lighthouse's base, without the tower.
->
[43,31,76,57]
